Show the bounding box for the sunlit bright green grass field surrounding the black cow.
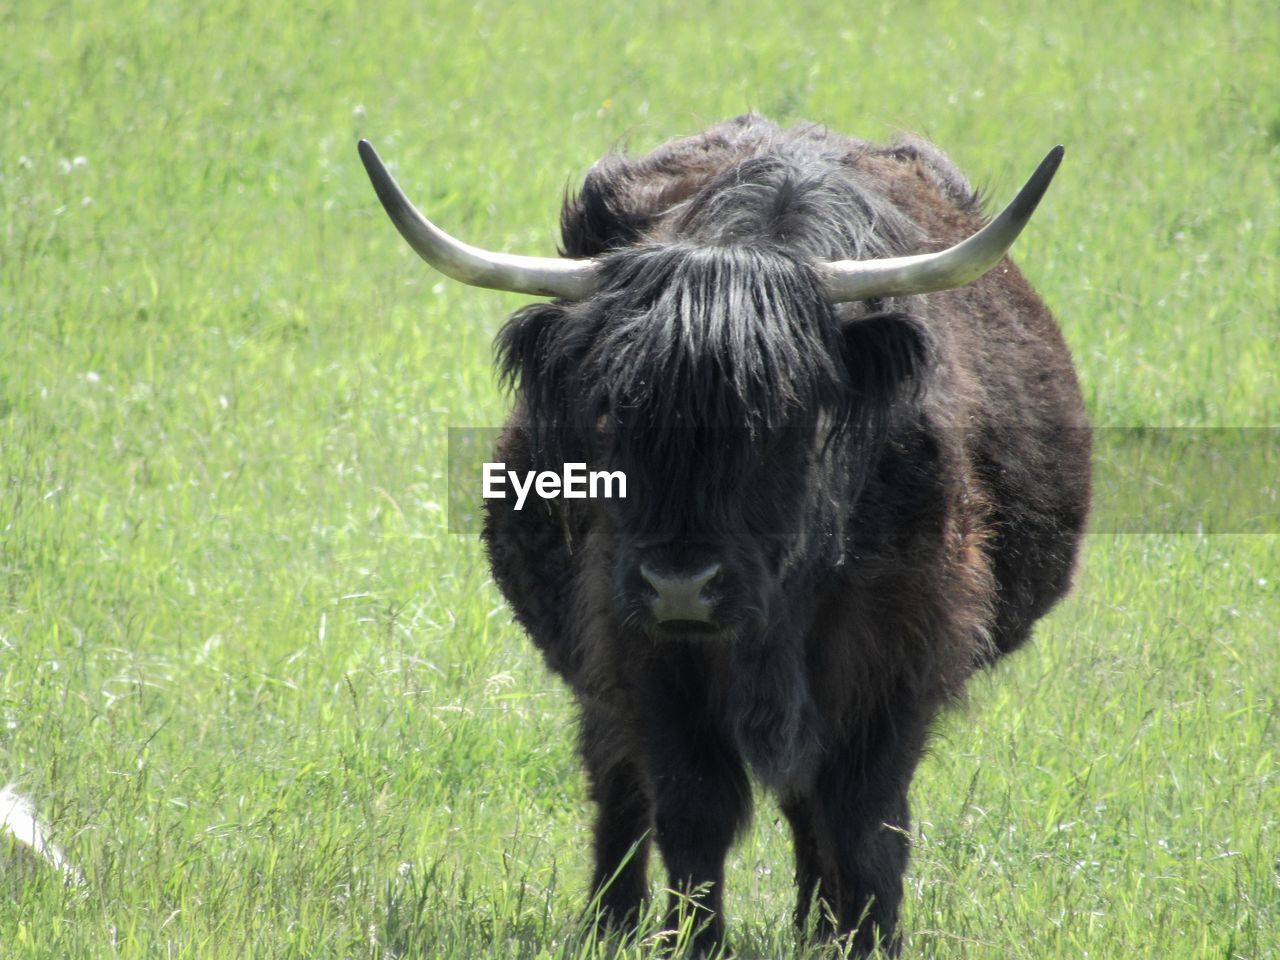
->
[0,0,1280,960]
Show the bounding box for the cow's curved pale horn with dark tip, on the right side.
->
[818,146,1062,303]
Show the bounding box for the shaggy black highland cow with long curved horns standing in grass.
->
[361,115,1089,952]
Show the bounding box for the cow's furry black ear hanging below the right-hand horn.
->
[844,314,933,404]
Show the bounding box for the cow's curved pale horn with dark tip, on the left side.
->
[360,140,599,300]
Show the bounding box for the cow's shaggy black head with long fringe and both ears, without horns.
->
[499,247,927,636]
